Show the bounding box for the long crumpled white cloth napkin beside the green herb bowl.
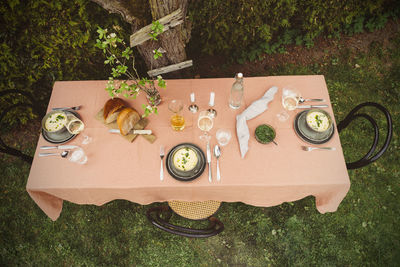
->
[236,86,278,158]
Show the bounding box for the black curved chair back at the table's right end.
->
[337,102,393,170]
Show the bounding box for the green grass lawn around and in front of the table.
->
[0,28,400,266]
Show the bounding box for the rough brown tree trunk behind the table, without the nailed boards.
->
[92,0,191,75]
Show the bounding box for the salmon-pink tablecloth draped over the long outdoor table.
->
[26,76,350,220]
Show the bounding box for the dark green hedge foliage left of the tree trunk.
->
[0,0,130,129]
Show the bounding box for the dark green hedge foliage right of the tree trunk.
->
[190,0,400,62]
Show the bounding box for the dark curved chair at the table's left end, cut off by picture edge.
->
[0,89,44,164]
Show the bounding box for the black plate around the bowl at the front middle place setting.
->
[165,143,206,182]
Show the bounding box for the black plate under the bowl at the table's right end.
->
[294,110,335,145]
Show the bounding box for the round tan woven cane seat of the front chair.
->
[168,200,221,220]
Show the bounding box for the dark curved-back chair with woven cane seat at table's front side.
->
[147,200,224,238]
